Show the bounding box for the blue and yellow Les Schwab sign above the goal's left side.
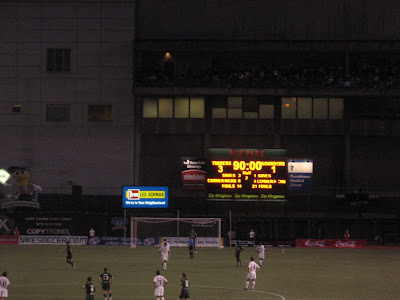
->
[122,185,168,208]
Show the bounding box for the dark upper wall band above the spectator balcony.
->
[137,0,400,40]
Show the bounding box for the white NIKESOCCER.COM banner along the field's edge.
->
[18,235,88,245]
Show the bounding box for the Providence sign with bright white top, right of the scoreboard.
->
[288,159,313,192]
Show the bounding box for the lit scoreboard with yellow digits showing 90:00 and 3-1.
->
[206,148,288,201]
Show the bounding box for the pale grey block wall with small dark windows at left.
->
[0,0,135,194]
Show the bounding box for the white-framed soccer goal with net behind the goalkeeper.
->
[130,217,223,248]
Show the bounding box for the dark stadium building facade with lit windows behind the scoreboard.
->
[0,0,400,238]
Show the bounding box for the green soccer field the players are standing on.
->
[0,245,400,300]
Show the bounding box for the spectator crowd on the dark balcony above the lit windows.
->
[136,60,400,88]
